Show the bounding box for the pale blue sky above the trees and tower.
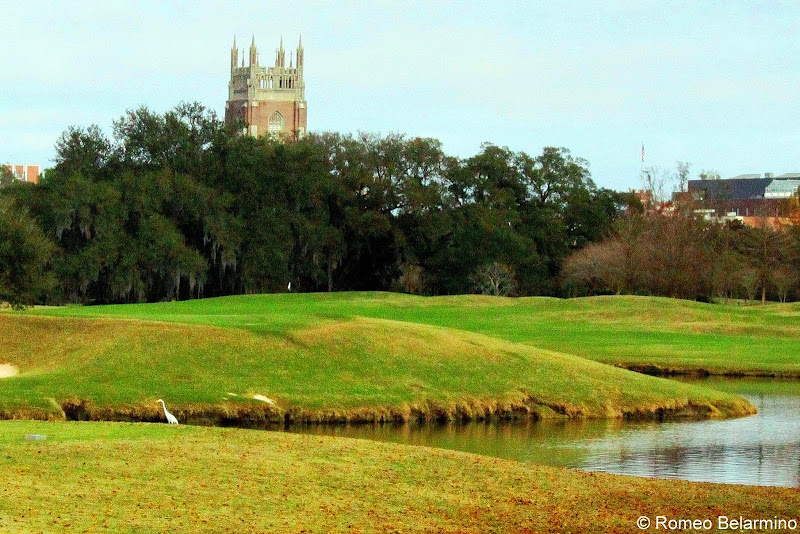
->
[0,0,800,190]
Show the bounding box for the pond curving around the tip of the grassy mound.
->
[290,378,800,487]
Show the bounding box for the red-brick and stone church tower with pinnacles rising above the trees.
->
[225,36,306,140]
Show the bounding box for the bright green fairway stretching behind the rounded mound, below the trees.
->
[31,293,800,376]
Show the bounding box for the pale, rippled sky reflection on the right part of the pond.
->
[572,394,800,487]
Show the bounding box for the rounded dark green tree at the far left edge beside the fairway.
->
[0,197,55,308]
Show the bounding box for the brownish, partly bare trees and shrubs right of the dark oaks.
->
[562,213,800,302]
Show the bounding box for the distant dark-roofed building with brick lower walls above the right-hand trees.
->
[689,173,800,219]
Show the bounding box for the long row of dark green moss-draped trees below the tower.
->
[0,103,636,304]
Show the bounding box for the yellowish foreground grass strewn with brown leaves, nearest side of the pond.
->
[0,422,800,533]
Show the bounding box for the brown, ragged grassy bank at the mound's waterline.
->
[37,395,756,428]
